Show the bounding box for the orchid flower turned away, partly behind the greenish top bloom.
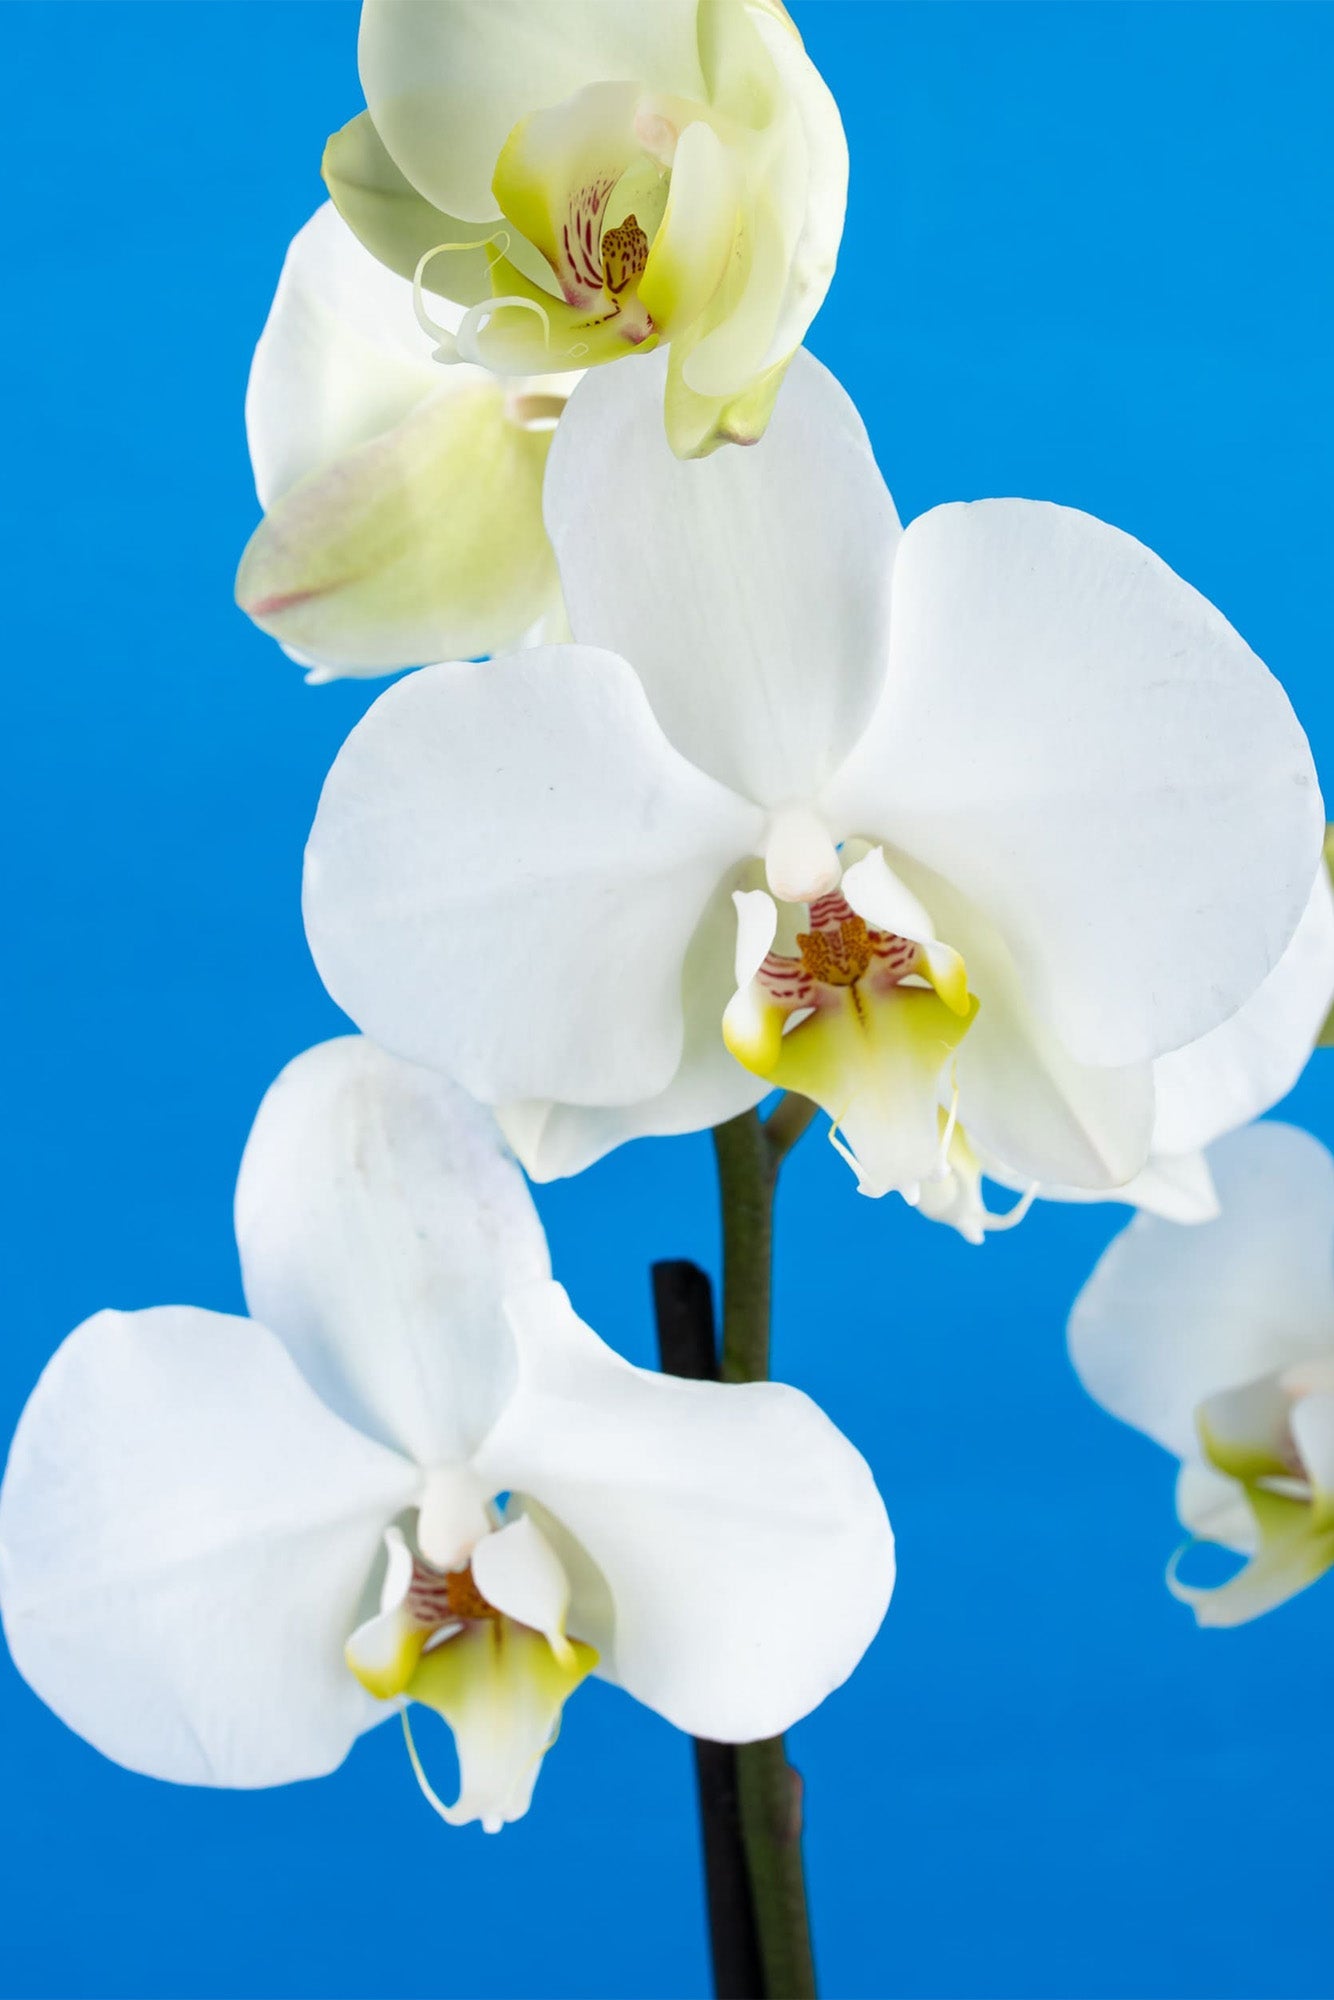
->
[236,202,576,680]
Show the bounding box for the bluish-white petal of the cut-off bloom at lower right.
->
[1070,1124,1334,1458]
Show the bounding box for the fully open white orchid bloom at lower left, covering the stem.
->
[0,1038,894,1830]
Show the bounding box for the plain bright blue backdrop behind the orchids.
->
[0,0,1334,1996]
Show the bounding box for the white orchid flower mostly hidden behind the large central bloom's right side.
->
[920,864,1334,1242]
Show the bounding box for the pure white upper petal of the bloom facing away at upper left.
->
[246,202,444,508]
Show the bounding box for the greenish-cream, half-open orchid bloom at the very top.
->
[324,0,848,456]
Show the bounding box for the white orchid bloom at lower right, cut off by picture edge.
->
[1070,1124,1334,1626]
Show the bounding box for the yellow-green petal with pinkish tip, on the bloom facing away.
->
[236,370,558,674]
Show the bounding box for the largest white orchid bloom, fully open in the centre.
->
[306,354,1324,1200]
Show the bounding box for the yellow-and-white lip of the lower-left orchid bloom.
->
[408,1618,598,1834]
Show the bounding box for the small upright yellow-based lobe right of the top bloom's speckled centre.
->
[640,118,740,338]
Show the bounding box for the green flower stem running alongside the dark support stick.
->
[714,1098,816,2000]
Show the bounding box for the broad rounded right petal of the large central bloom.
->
[824,500,1324,1064]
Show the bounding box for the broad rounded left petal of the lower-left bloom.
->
[0,1306,418,1786]
